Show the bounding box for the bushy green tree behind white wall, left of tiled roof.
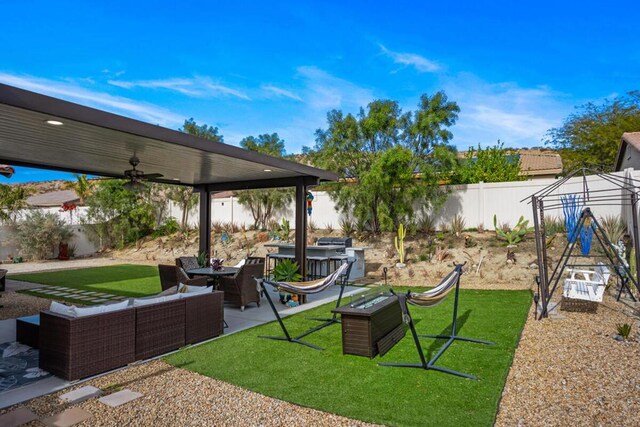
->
[451,141,527,184]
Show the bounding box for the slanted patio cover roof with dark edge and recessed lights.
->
[0,84,337,191]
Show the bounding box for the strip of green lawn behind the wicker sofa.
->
[9,264,162,304]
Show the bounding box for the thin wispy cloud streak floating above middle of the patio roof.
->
[108,77,251,100]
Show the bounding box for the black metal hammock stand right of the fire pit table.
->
[379,264,495,380]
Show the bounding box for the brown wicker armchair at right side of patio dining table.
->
[218,257,264,311]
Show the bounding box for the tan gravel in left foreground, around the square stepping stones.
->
[0,361,378,427]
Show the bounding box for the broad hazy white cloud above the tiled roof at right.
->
[443,74,572,149]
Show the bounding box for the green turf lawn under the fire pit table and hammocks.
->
[165,288,531,426]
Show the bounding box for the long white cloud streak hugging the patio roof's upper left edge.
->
[0,72,183,126]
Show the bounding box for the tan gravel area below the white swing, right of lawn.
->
[496,295,640,426]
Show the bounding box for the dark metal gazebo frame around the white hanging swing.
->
[521,168,640,318]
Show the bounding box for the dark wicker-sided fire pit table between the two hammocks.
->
[332,293,404,358]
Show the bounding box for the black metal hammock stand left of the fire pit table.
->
[258,260,354,350]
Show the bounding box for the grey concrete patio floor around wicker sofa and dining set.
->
[0,282,366,409]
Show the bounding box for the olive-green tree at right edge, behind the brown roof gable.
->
[545,91,640,172]
